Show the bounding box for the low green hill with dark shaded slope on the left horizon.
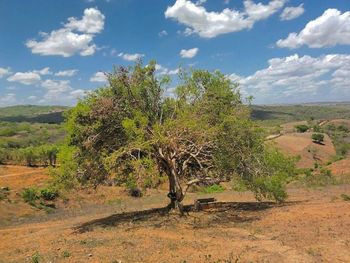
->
[0,105,68,123]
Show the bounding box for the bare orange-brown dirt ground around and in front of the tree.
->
[0,167,350,263]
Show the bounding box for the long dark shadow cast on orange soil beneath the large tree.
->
[73,202,295,233]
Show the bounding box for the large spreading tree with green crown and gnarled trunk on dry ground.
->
[58,62,294,213]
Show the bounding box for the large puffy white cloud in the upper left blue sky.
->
[26,8,105,57]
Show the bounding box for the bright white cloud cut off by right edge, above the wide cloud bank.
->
[277,9,350,48]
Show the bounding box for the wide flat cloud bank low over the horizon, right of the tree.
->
[230,54,350,103]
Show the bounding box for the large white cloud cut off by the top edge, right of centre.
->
[165,0,286,38]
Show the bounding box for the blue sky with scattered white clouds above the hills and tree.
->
[0,0,350,107]
